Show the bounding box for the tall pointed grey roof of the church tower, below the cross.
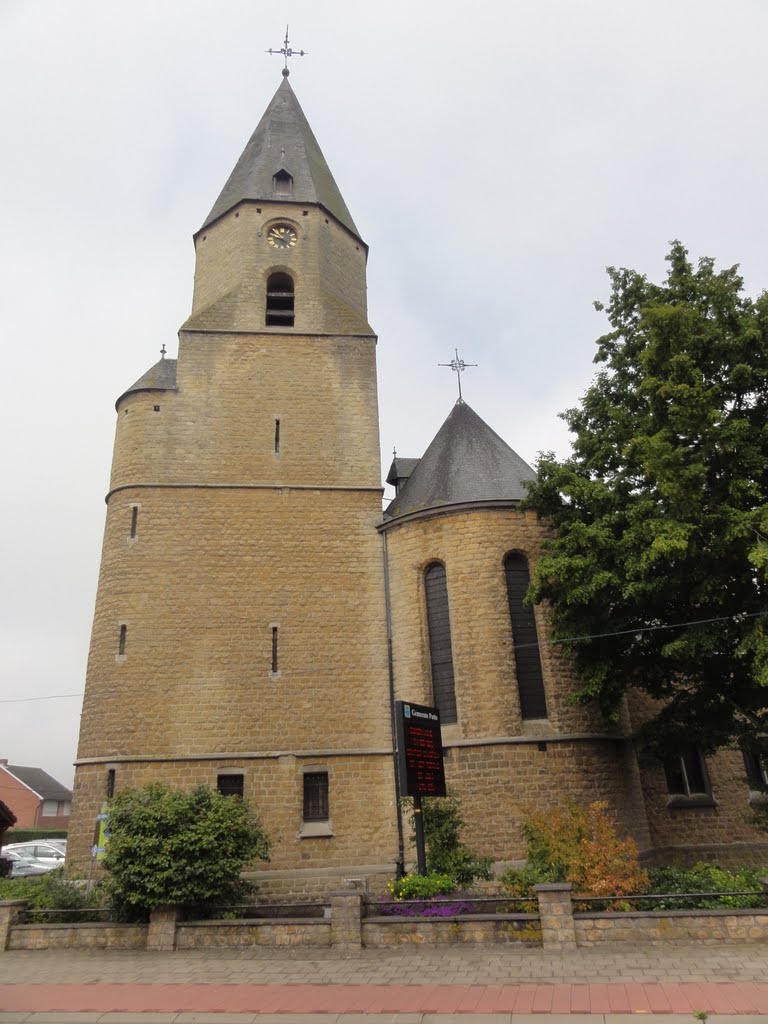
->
[201,78,359,238]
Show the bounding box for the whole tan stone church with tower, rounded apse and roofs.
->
[69,73,760,891]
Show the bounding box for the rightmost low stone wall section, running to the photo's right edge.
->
[573,910,768,946]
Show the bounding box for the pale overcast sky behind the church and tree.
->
[0,0,768,799]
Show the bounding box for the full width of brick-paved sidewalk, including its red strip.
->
[0,943,768,1024]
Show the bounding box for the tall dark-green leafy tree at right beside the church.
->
[526,242,768,757]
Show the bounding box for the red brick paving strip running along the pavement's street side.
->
[0,981,768,1016]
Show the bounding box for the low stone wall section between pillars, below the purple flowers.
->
[362,913,542,947]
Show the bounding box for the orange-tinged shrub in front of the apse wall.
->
[502,801,649,896]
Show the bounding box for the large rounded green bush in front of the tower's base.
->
[103,783,269,916]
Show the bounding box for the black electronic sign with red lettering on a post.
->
[394,700,445,874]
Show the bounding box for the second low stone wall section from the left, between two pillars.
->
[176,918,331,949]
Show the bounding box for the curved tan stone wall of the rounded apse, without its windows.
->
[386,509,650,860]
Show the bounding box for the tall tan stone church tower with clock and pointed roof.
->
[70,73,397,879]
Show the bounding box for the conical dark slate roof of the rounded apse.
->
[384,398,536,520]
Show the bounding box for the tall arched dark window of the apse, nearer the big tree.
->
[504,552,547,719]
